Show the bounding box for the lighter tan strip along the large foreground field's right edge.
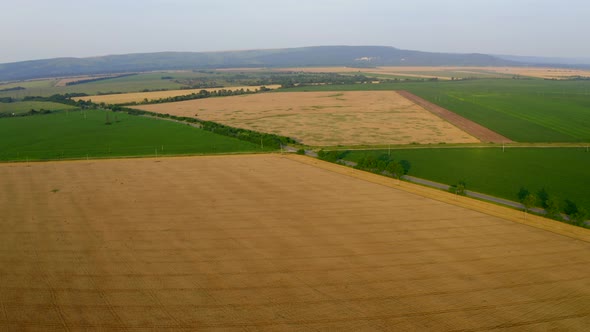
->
[285,154,590,243]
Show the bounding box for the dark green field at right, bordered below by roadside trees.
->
[345,147,590,210]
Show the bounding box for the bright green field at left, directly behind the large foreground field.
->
[0,110,268,161]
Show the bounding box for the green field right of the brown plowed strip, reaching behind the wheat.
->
[283,79,590,142]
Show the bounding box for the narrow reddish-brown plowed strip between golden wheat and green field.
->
[398,91,512,143]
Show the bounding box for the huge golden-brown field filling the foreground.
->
[0,155,590,331]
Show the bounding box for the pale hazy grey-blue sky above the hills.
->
[0,0,590,63]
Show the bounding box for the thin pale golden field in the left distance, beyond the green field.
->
[74,84,280,104]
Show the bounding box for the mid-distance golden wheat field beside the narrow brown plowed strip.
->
[136,91,479,146]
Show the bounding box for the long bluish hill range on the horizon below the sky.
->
[0,46,588,81]
